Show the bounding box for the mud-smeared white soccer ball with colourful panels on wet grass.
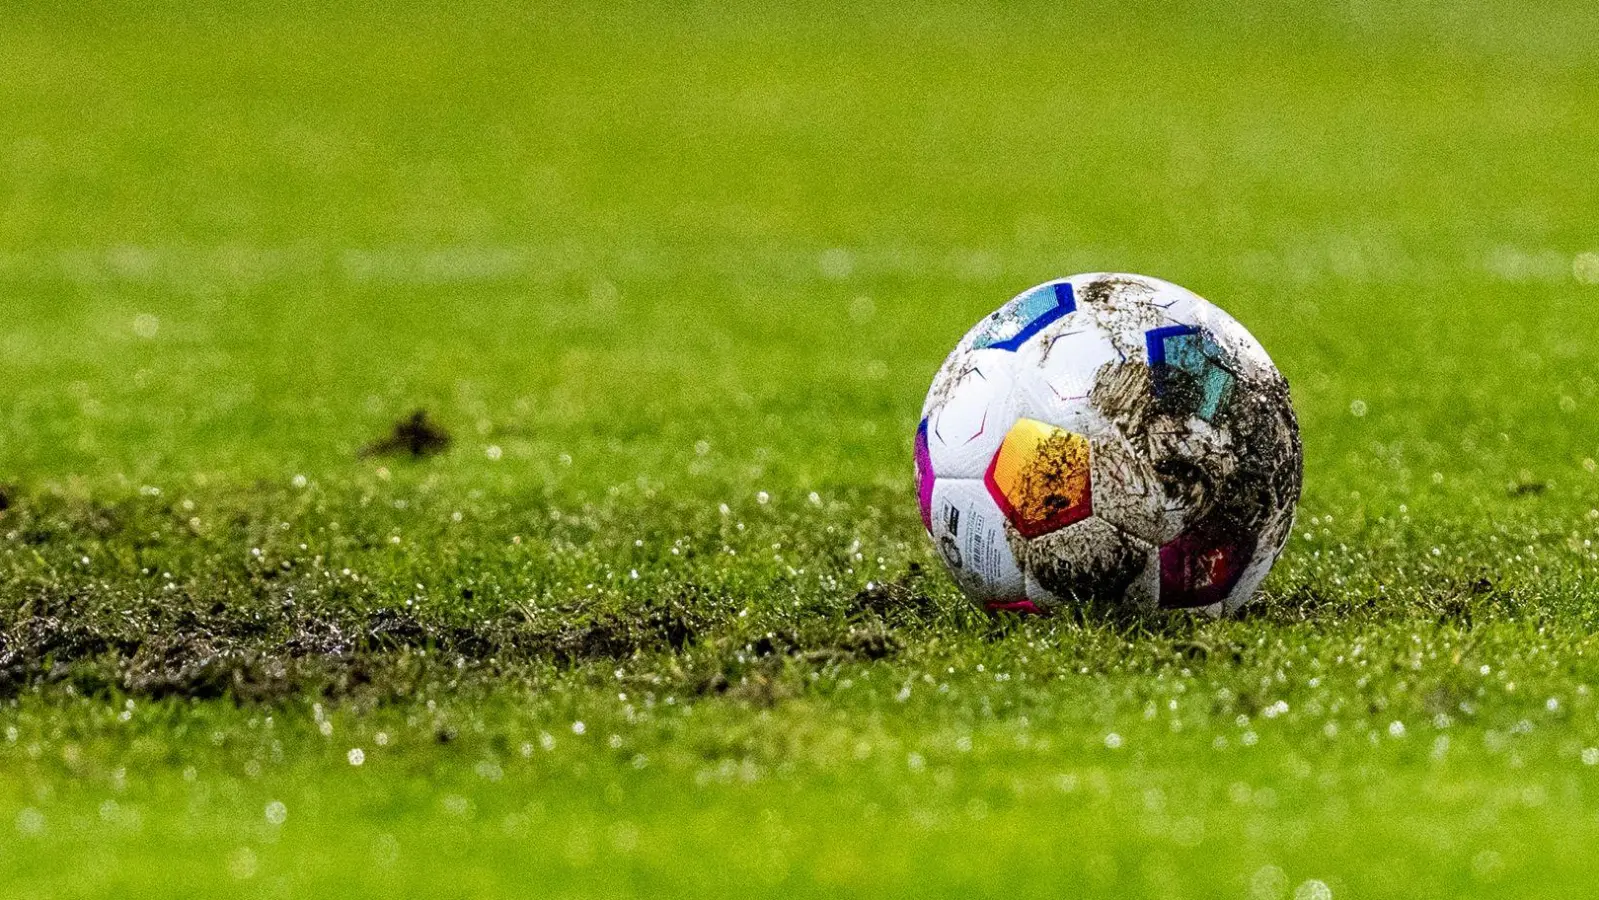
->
[916,273,1303,615]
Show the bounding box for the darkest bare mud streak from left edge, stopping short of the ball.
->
[0,596,707,702]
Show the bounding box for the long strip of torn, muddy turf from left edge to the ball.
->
[0,559,940,703]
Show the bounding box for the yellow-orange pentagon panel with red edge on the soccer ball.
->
[983,419,1094,537]
